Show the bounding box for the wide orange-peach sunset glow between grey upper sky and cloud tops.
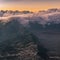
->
[0,2,60,12]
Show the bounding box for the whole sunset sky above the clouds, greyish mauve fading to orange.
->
[0,0,60,12]
